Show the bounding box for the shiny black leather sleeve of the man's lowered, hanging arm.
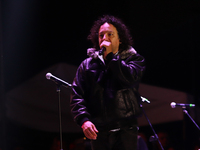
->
[70,60,90,126]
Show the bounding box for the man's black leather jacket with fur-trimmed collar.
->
[70,47,145,130]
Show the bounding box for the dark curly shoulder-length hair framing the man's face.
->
[88,15,133,51]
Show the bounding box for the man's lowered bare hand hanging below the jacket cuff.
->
[81,121,99,140]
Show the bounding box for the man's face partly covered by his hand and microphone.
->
[99,22,120,54]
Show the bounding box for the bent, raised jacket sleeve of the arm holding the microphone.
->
[107,54,145,86]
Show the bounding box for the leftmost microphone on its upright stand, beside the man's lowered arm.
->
[46,73,71,150]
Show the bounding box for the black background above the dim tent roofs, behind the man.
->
[0,0,200,149]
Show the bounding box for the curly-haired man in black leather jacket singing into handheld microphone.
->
[70,15,145,150]
